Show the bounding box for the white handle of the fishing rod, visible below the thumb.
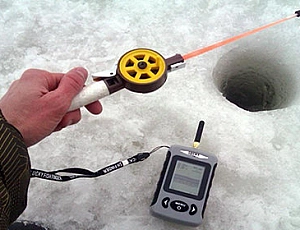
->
[68,81,110,111]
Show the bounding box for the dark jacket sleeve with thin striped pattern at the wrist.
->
[0,110,30,230]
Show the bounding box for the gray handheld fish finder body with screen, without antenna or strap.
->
[150,145,218,226]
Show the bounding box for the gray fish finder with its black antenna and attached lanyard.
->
[31,121,218,226]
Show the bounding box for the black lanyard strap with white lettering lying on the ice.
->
[30,145,169,182]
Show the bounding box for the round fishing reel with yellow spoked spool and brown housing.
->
[117,49,167,93]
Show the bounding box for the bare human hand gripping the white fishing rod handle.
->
[0,67,102,147]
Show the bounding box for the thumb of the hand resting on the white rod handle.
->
[57,67,88,101]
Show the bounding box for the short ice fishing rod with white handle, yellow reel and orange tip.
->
[69,10,300,111]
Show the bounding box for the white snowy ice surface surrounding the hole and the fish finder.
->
[0,0,300,230]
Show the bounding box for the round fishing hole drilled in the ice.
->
[213,48,295,112]
